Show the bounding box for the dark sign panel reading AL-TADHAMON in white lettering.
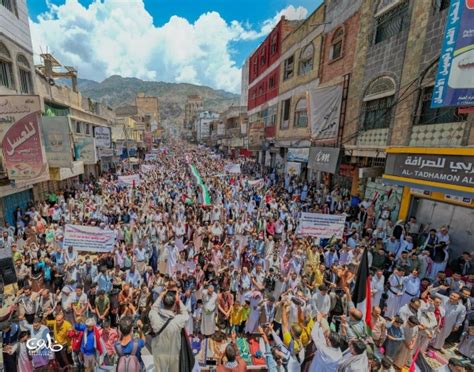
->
[385,154,474,187]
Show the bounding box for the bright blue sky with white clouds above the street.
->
[27,0,322,93]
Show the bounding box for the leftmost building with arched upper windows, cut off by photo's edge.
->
[0,0,44,225]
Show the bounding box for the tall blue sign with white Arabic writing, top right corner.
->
[431,0,474,108]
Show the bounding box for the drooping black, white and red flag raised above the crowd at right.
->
[352,248,372,327]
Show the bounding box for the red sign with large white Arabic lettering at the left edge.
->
[2,112,47,180]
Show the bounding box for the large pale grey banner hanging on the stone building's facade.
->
[310,85,342,140]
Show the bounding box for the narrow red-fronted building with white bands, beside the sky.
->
[243,17,301,159]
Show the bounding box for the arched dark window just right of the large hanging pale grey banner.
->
[363,76,396,130]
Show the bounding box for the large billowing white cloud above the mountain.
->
[30,0,308,92]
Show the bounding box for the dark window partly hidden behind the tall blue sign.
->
[415,87,467,124]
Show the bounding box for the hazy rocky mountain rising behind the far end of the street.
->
[68,75,240,126]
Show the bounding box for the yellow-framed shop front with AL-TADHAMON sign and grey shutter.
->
[383,147,474,256]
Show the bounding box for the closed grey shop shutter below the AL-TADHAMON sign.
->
[410,198,474,259]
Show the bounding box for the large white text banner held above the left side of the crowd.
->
[64,225,116,253]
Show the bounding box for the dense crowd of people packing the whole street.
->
[0,141,474,372]
